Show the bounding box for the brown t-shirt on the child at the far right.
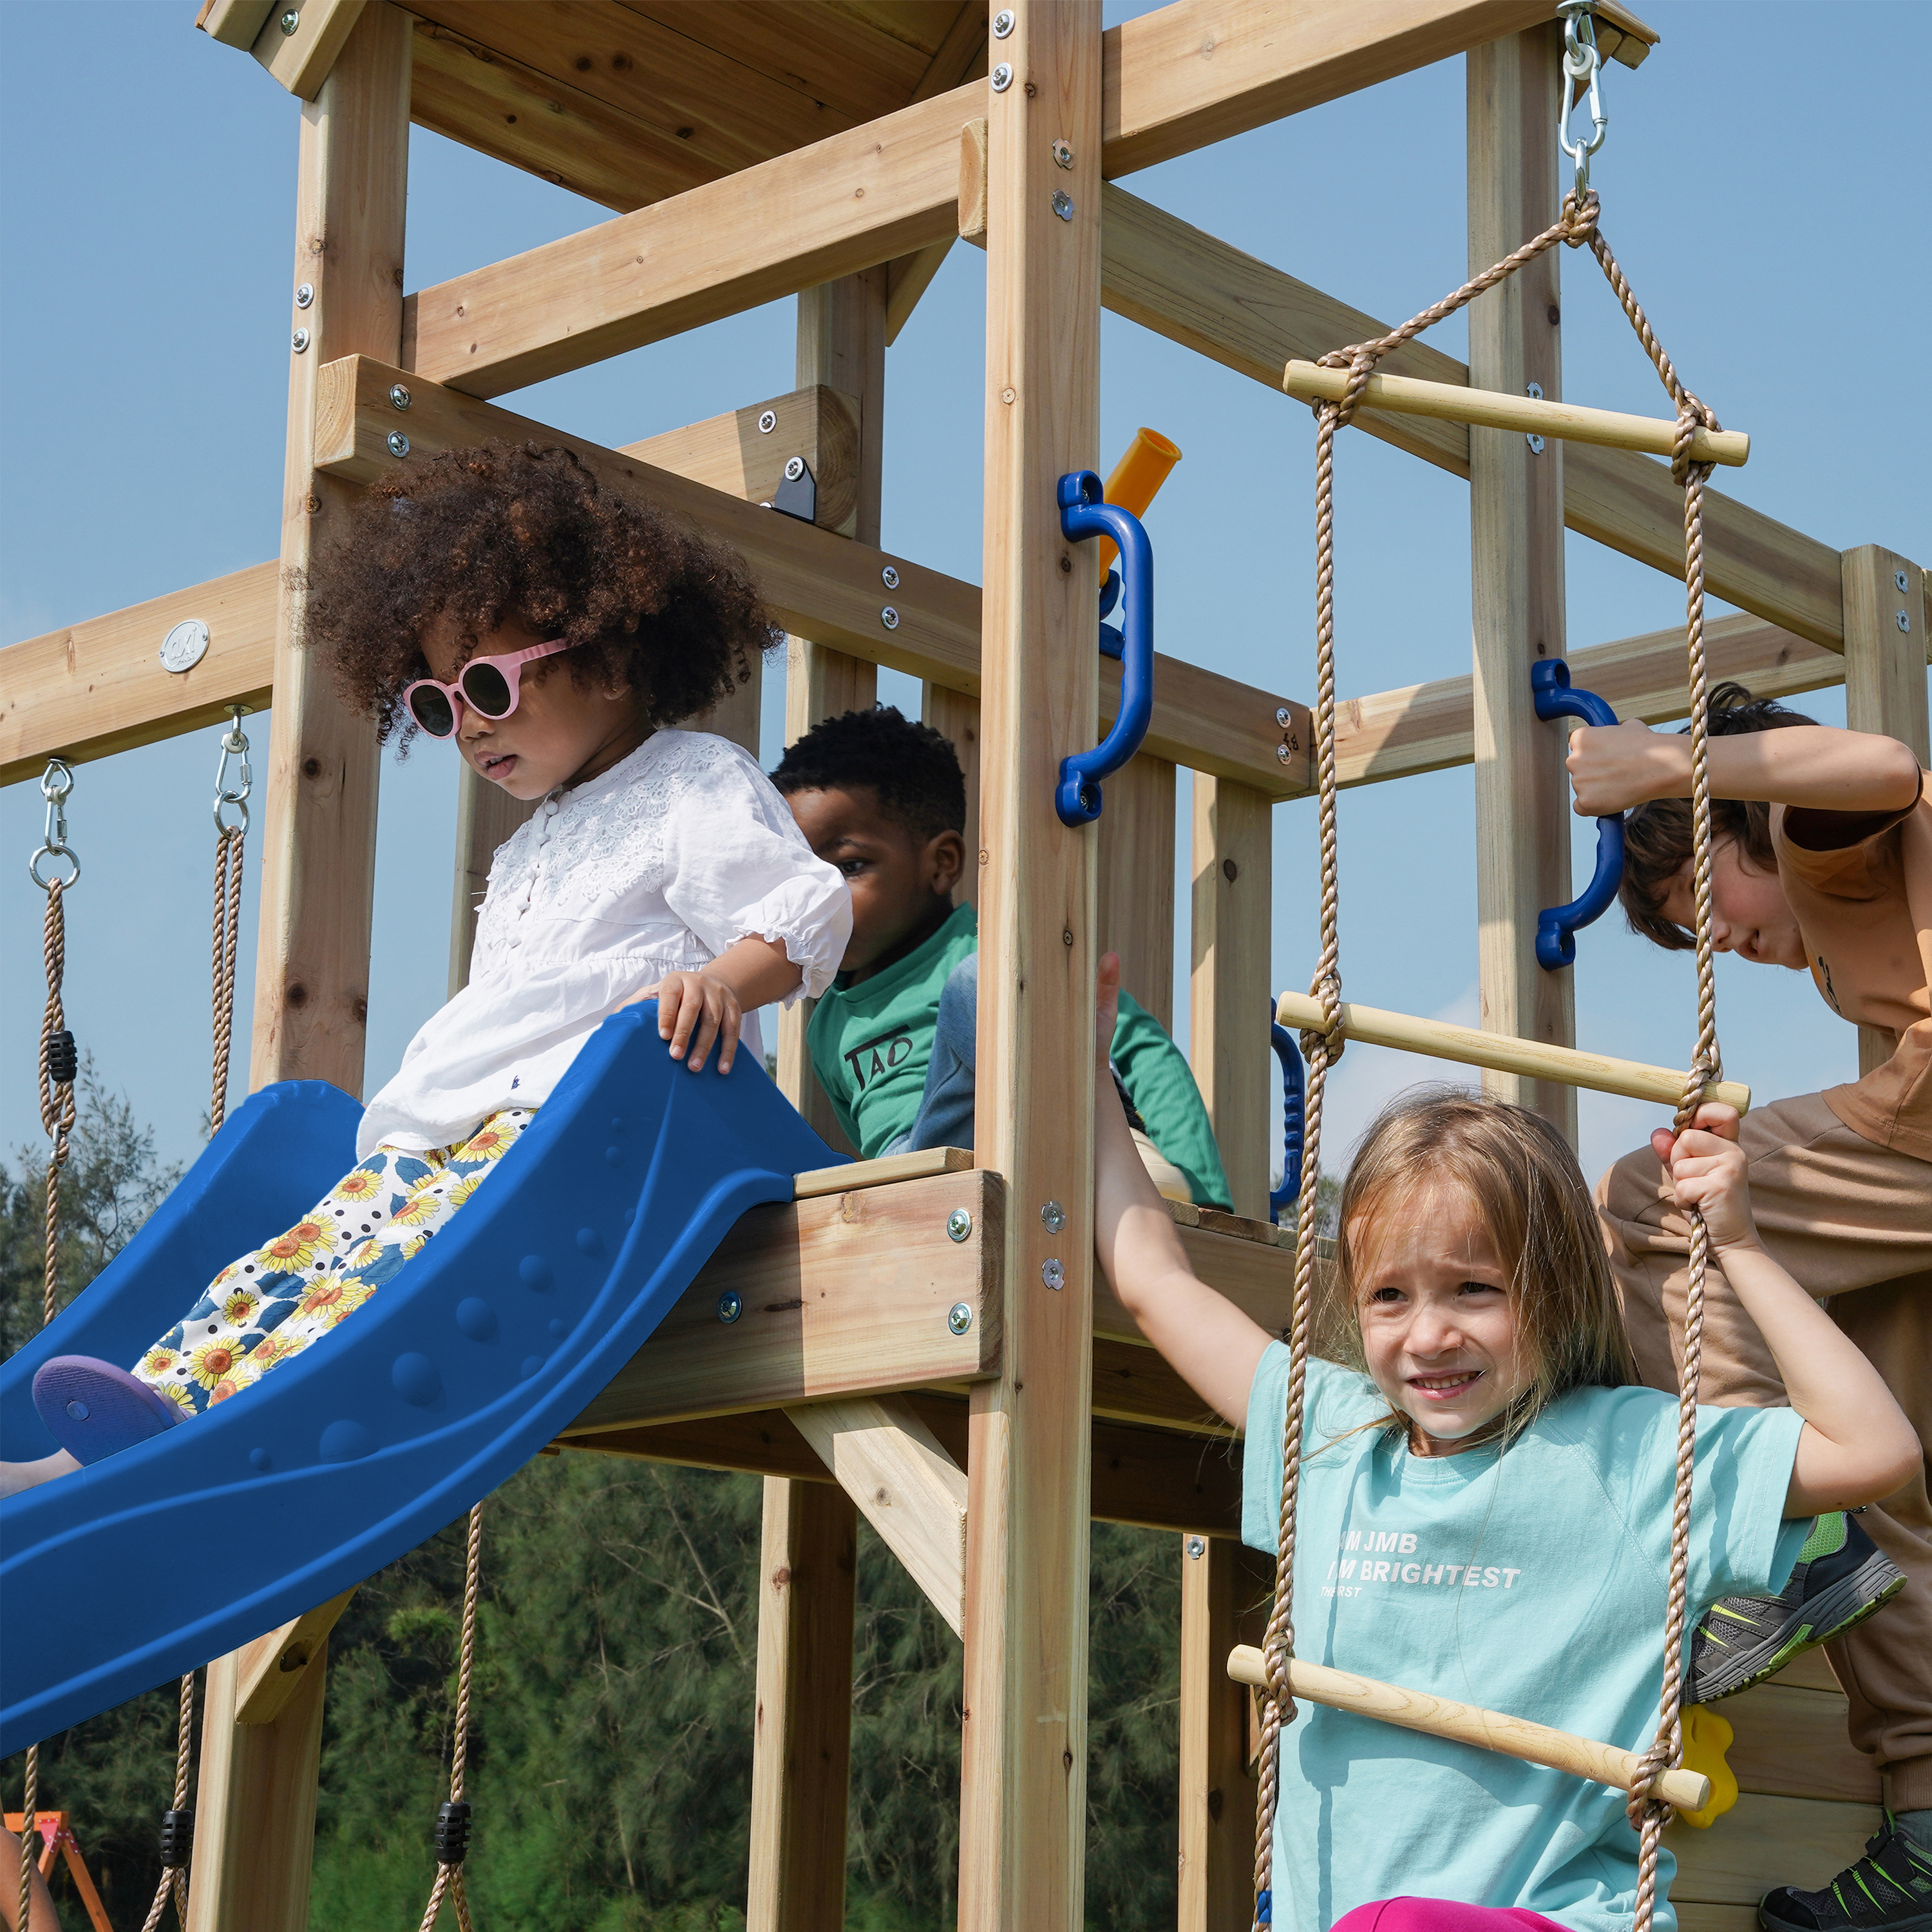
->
[1772,775,1932,1161]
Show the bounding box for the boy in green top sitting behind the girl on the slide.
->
[771,707,1229,1208]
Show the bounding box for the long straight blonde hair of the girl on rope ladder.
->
[1323,1086,1638,1439]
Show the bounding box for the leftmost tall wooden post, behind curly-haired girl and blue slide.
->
[189,15,410,1932]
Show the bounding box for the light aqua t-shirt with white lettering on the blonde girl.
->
[1242,1343,1812,1932]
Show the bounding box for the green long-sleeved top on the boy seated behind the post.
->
[806,906,1229,1208]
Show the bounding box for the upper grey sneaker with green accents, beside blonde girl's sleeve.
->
[1685,1509,1905,1704]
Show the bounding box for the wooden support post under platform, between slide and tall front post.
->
[746,1476,858,1932]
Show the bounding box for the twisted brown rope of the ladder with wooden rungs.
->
[1254,192,1721,1932]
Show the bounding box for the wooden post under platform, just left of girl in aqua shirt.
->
[1180,1536,1273,1932]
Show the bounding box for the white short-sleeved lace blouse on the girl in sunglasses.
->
[355,730,852,1159]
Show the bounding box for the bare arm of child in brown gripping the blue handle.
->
[1569,723,1918,817]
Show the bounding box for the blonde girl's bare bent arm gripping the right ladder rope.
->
[1650,1113,1920,1517]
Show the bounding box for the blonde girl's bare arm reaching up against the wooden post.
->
[1094,952,1269,1428]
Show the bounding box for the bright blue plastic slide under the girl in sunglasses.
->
[0,1003,838,1756]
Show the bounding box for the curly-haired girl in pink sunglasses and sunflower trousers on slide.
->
[13,442,852,1493]
